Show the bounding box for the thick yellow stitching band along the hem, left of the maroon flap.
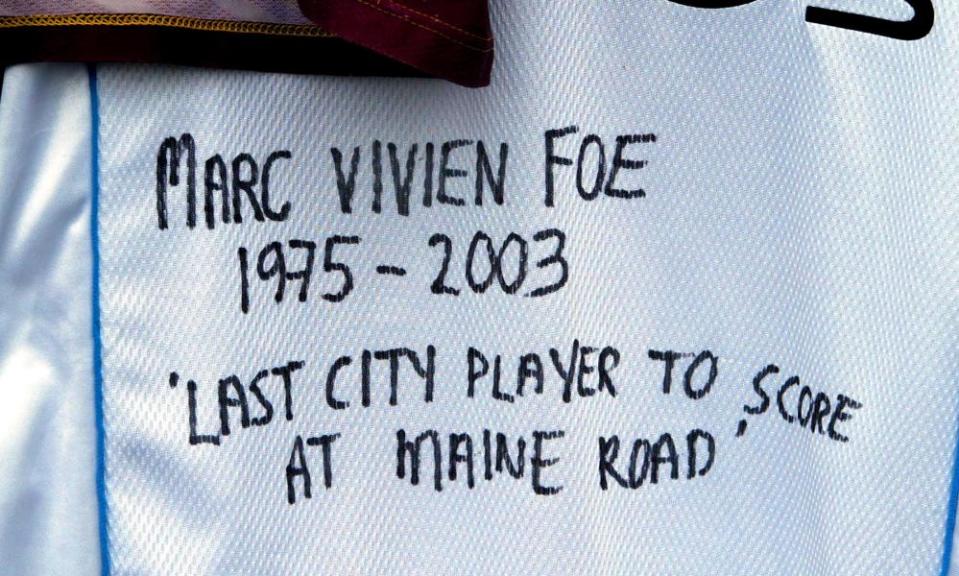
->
[0,14,333,38]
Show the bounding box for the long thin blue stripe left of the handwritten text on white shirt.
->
[87,64,110,576]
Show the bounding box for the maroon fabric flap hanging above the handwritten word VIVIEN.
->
[299,0,493,87]
